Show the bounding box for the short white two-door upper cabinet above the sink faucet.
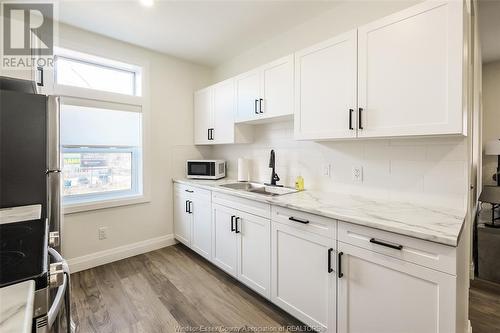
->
[235,55,293,122]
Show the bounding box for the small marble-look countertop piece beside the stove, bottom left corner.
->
[0,280,35,333]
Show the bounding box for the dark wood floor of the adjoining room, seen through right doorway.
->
[469,279,500,333]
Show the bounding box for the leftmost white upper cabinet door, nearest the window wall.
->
[194,87,213,145]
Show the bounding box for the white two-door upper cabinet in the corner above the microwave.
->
[194,79,253,145]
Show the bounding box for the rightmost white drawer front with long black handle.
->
[338,221,456,275]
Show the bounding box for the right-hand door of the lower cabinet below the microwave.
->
[191,189,212,260]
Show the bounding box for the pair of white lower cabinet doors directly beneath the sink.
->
[212,204,271,298]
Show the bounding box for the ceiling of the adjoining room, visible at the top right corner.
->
[478,0,500,63]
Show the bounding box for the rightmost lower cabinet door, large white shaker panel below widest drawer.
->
[337,242,456,333]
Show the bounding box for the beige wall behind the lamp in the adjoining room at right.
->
[483,61,500,185]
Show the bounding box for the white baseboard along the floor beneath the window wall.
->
[67,234,177,273]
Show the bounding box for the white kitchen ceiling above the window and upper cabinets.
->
[59,0,335,66]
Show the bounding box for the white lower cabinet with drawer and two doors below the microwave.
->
[174,184,212,260]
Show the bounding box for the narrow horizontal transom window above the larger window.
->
[55,49,141,96]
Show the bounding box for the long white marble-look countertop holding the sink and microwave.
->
[174,179,465,246]
